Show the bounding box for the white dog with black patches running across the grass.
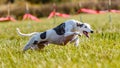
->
[17,20,93,51]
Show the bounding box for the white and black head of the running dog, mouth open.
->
[77,23,94,38]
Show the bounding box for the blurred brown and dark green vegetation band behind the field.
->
[0,0,120,20]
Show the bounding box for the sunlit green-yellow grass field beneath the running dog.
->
[0,14,120,68]
